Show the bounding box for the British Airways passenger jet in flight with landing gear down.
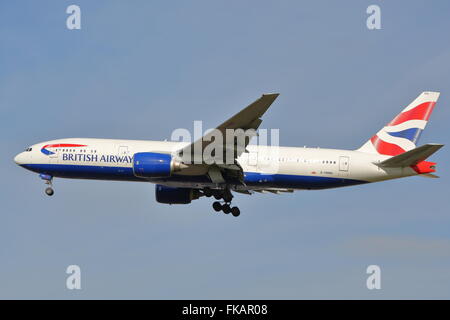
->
[14,92,443,216]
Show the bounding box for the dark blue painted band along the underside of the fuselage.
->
[22,164,367,189]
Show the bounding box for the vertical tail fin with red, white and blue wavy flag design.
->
[358,92,440,156]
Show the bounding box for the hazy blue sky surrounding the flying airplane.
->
[0,0,450,299]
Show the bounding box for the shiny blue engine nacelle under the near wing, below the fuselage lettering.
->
[133,152,187,178]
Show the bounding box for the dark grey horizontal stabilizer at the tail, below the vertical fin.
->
[377,143,444,167]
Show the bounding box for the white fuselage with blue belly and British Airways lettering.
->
[15,138,417,190]
